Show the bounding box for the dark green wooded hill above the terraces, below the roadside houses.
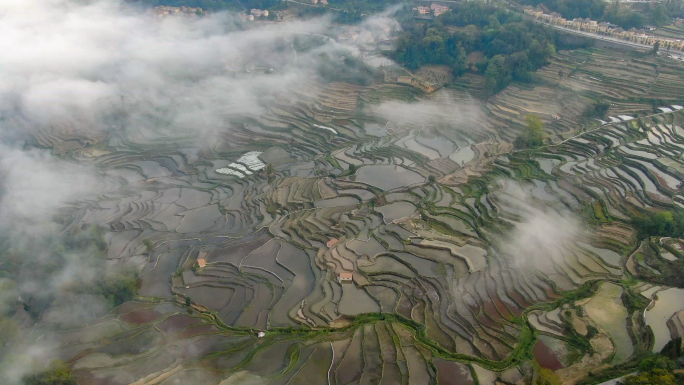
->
[393,3,556,94]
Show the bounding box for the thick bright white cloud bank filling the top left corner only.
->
[0,0,329,134]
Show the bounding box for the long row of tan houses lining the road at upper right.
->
[525,7,684,51]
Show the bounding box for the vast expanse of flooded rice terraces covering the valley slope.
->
[32,51,684,385]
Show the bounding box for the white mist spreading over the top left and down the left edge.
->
[0,0,408,384]
